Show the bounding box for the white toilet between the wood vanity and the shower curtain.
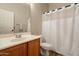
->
[40,42,52,56]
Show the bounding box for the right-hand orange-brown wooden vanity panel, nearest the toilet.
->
[28,39,40,56]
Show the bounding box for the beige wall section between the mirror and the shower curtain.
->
[31,3,48,34]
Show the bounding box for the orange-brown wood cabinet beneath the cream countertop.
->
[0,39,40,56]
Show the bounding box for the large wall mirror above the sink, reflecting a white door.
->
[0,3,30,34]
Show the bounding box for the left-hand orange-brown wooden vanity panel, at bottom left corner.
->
[0,44,27,56]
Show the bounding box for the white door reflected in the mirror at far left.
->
[0,9,14,34]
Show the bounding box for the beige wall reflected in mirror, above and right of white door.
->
[0,3,30,32]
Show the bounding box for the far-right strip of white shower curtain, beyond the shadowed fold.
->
[71,4,79,56]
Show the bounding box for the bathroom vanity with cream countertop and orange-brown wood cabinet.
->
[0,35,40,56]
